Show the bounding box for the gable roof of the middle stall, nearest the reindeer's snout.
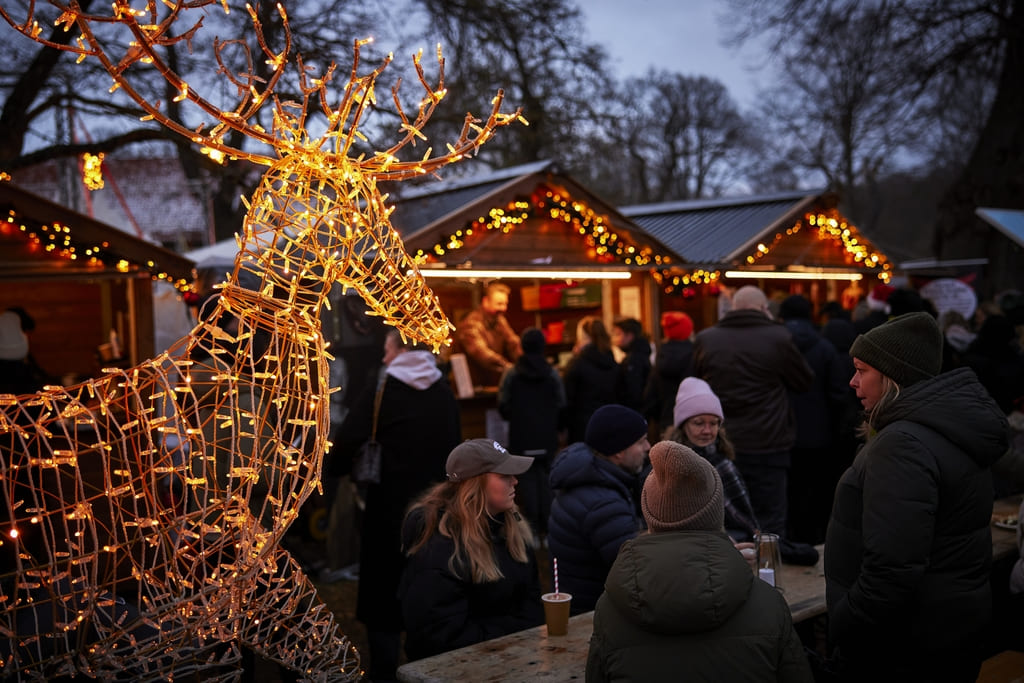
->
[391,161,679,265]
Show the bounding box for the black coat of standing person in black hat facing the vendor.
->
[498,353,565,457]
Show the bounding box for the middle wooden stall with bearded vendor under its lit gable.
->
[391,161,676,436]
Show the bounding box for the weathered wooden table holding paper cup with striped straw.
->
[398,496,1021,683]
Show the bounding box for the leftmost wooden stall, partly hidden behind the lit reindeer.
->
[0,182,194,380]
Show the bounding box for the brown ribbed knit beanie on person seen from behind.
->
[640,441,725,531]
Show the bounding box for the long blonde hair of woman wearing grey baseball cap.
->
[406,475,534,584]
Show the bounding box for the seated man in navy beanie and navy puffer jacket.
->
[548,403,650,614]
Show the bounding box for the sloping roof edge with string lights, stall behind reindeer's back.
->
[0,182,194,283]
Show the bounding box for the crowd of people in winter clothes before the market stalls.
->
[319,286,1024,682]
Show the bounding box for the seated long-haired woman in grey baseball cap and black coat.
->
[398,438,544,659]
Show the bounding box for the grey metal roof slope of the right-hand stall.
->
[621,190,822,264]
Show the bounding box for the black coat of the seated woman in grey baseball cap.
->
[397,513,544,659]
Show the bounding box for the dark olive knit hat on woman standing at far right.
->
[850,312,942,387]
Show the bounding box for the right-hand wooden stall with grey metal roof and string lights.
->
[622,190,893,329]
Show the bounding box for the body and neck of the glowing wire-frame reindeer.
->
[0,156,366,680]
